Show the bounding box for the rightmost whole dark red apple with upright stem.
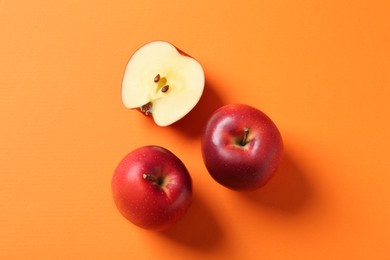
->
[201,104,283,190]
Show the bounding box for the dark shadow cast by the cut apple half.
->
[172,75,224,138]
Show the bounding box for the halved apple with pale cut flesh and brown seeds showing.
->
[122,41,205,126]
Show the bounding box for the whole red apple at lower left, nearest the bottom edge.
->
[111,145,192,231]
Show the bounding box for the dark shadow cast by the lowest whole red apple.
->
[161,194,223,251]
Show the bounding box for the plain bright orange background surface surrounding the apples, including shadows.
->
[0,0,390,259]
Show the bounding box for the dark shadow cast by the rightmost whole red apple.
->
[241,153,313,214]
